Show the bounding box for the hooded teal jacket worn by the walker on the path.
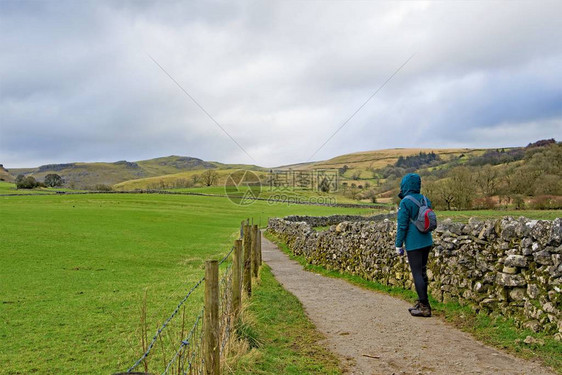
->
[396,173,433,251]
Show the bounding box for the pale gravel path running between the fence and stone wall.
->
[262,236,554,375]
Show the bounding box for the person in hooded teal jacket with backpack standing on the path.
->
[395,173,433,317]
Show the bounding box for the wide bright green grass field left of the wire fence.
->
[0,194,373,374]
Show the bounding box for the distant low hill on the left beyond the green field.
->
[10,155,259,188]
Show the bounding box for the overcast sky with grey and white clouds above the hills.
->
[0,0,562,168]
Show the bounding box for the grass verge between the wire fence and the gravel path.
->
[228,264,341,375]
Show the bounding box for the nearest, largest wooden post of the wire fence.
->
[203,260,220,375]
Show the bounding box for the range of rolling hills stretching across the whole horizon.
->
[5,139,562,209]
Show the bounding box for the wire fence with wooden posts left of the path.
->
[116,222,261,375]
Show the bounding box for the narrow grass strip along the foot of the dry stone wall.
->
[265,232,562,374]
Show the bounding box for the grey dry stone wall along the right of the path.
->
[268,215,562,340]
